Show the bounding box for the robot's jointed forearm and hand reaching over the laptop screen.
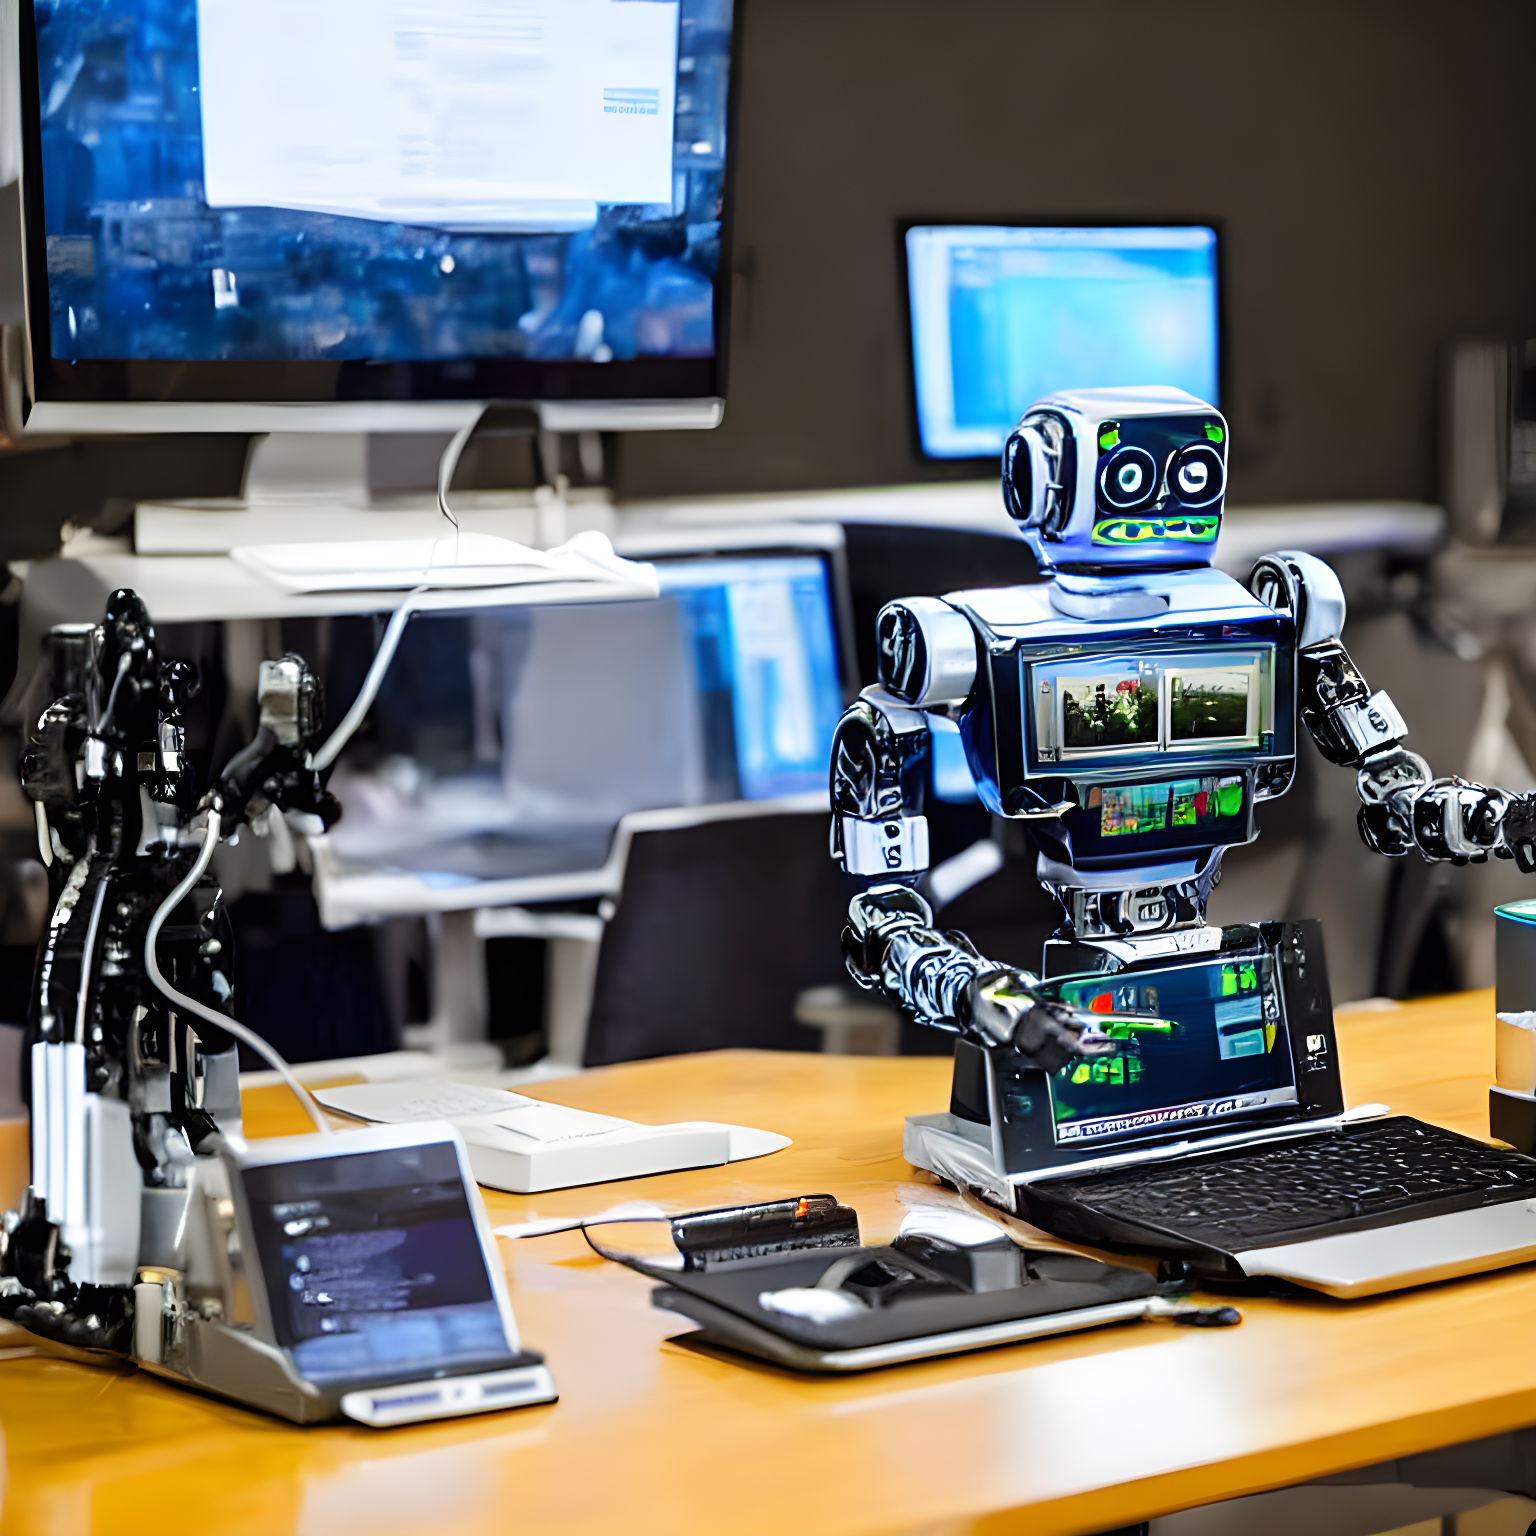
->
[843,885,1120,1072]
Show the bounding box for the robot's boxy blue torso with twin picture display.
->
[962,571,1296,865]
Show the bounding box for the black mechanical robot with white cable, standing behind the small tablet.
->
[0,590,341,1349]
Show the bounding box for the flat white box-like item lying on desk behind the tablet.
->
[315,1078,790,1195]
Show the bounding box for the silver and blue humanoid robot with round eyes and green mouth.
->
[831,387,1536,1192]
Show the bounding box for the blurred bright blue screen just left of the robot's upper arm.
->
[657,554,843,800]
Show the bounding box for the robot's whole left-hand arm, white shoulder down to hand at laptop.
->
[831,598,1118,1072]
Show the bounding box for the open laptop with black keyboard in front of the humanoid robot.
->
[906,922,1536,1296]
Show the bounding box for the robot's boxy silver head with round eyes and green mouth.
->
[1003,386,1227,573]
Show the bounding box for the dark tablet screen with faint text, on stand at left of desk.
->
[241,1141,513,1382]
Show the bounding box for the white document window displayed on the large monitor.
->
[197,0,679,230]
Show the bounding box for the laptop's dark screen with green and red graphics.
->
[1044,952,1296,1146]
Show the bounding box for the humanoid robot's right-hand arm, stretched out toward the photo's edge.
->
[1249,551,1536,874]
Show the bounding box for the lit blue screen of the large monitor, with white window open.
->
[32,0,731,362]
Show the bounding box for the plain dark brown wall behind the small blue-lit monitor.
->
[619,0,1536,504]
